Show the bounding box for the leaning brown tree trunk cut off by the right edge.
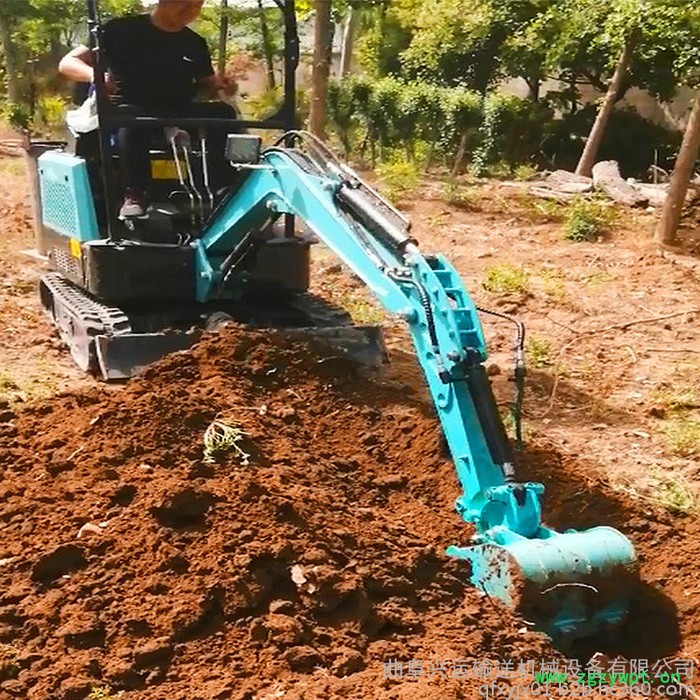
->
[656,91,700,244]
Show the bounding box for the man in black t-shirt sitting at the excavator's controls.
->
[58,0,237,218]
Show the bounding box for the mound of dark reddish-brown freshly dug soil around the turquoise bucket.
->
[0,328,700,700]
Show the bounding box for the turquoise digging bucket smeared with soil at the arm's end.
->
[447,527,638,648]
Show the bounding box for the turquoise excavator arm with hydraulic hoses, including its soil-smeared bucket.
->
[196,132,635,644]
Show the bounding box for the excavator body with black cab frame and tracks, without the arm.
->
[30,0,349,379]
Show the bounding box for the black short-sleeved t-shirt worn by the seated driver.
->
[102,15,214,107]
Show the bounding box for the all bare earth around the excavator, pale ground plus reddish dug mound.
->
[0,154,700,700]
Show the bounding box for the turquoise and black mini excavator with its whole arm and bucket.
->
[30,0,636,645]
